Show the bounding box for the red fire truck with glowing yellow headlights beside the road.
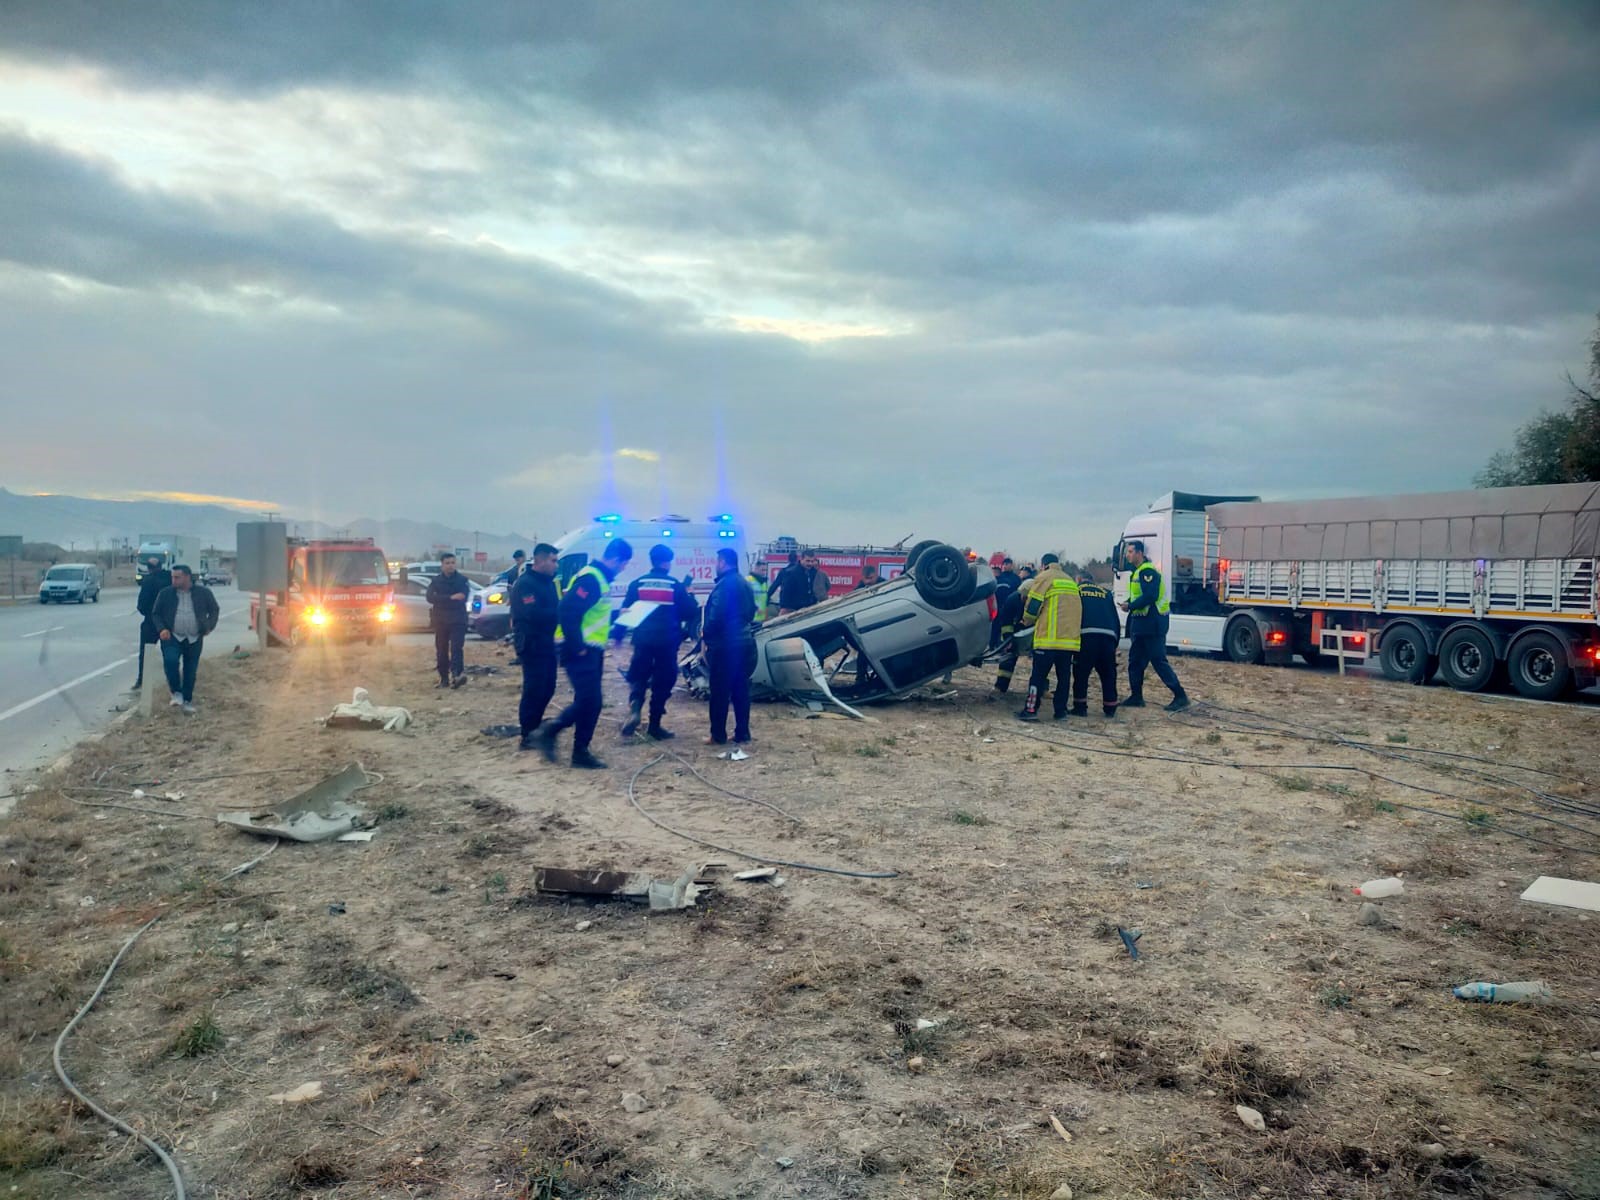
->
[250,538,395,646]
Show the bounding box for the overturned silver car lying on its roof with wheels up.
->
[683,542,995,710]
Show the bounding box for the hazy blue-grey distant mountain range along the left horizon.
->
[0,488,531,562]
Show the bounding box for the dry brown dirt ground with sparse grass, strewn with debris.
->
[0,643,1600,1200]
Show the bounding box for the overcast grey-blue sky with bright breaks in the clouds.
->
[0,0,1600,557]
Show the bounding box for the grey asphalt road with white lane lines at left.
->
[0,587,251,800]
